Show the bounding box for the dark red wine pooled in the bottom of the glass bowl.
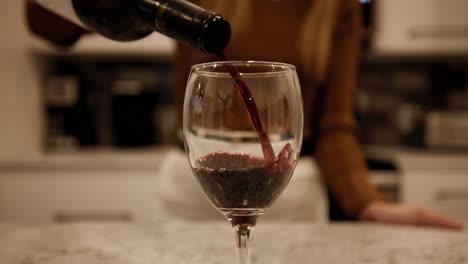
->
[192,152,293,211]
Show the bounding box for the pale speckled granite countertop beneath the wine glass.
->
[0,221,468,264]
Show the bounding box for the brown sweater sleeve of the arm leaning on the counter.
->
[315,0,380,218]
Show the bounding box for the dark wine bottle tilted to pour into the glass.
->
[29,0,231,53]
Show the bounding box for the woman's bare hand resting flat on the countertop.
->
[359,201,464,230]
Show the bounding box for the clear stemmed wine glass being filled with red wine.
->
[183,61,303,264]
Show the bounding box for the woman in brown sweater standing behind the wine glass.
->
[27,0,463,229]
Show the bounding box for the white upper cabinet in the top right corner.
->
[372,0,468,55]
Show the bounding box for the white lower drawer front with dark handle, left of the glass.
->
[0,171,161,222]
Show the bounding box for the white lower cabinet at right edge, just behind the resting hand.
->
[399,153,468,221]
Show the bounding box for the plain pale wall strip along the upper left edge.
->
[0,0,42,160]
